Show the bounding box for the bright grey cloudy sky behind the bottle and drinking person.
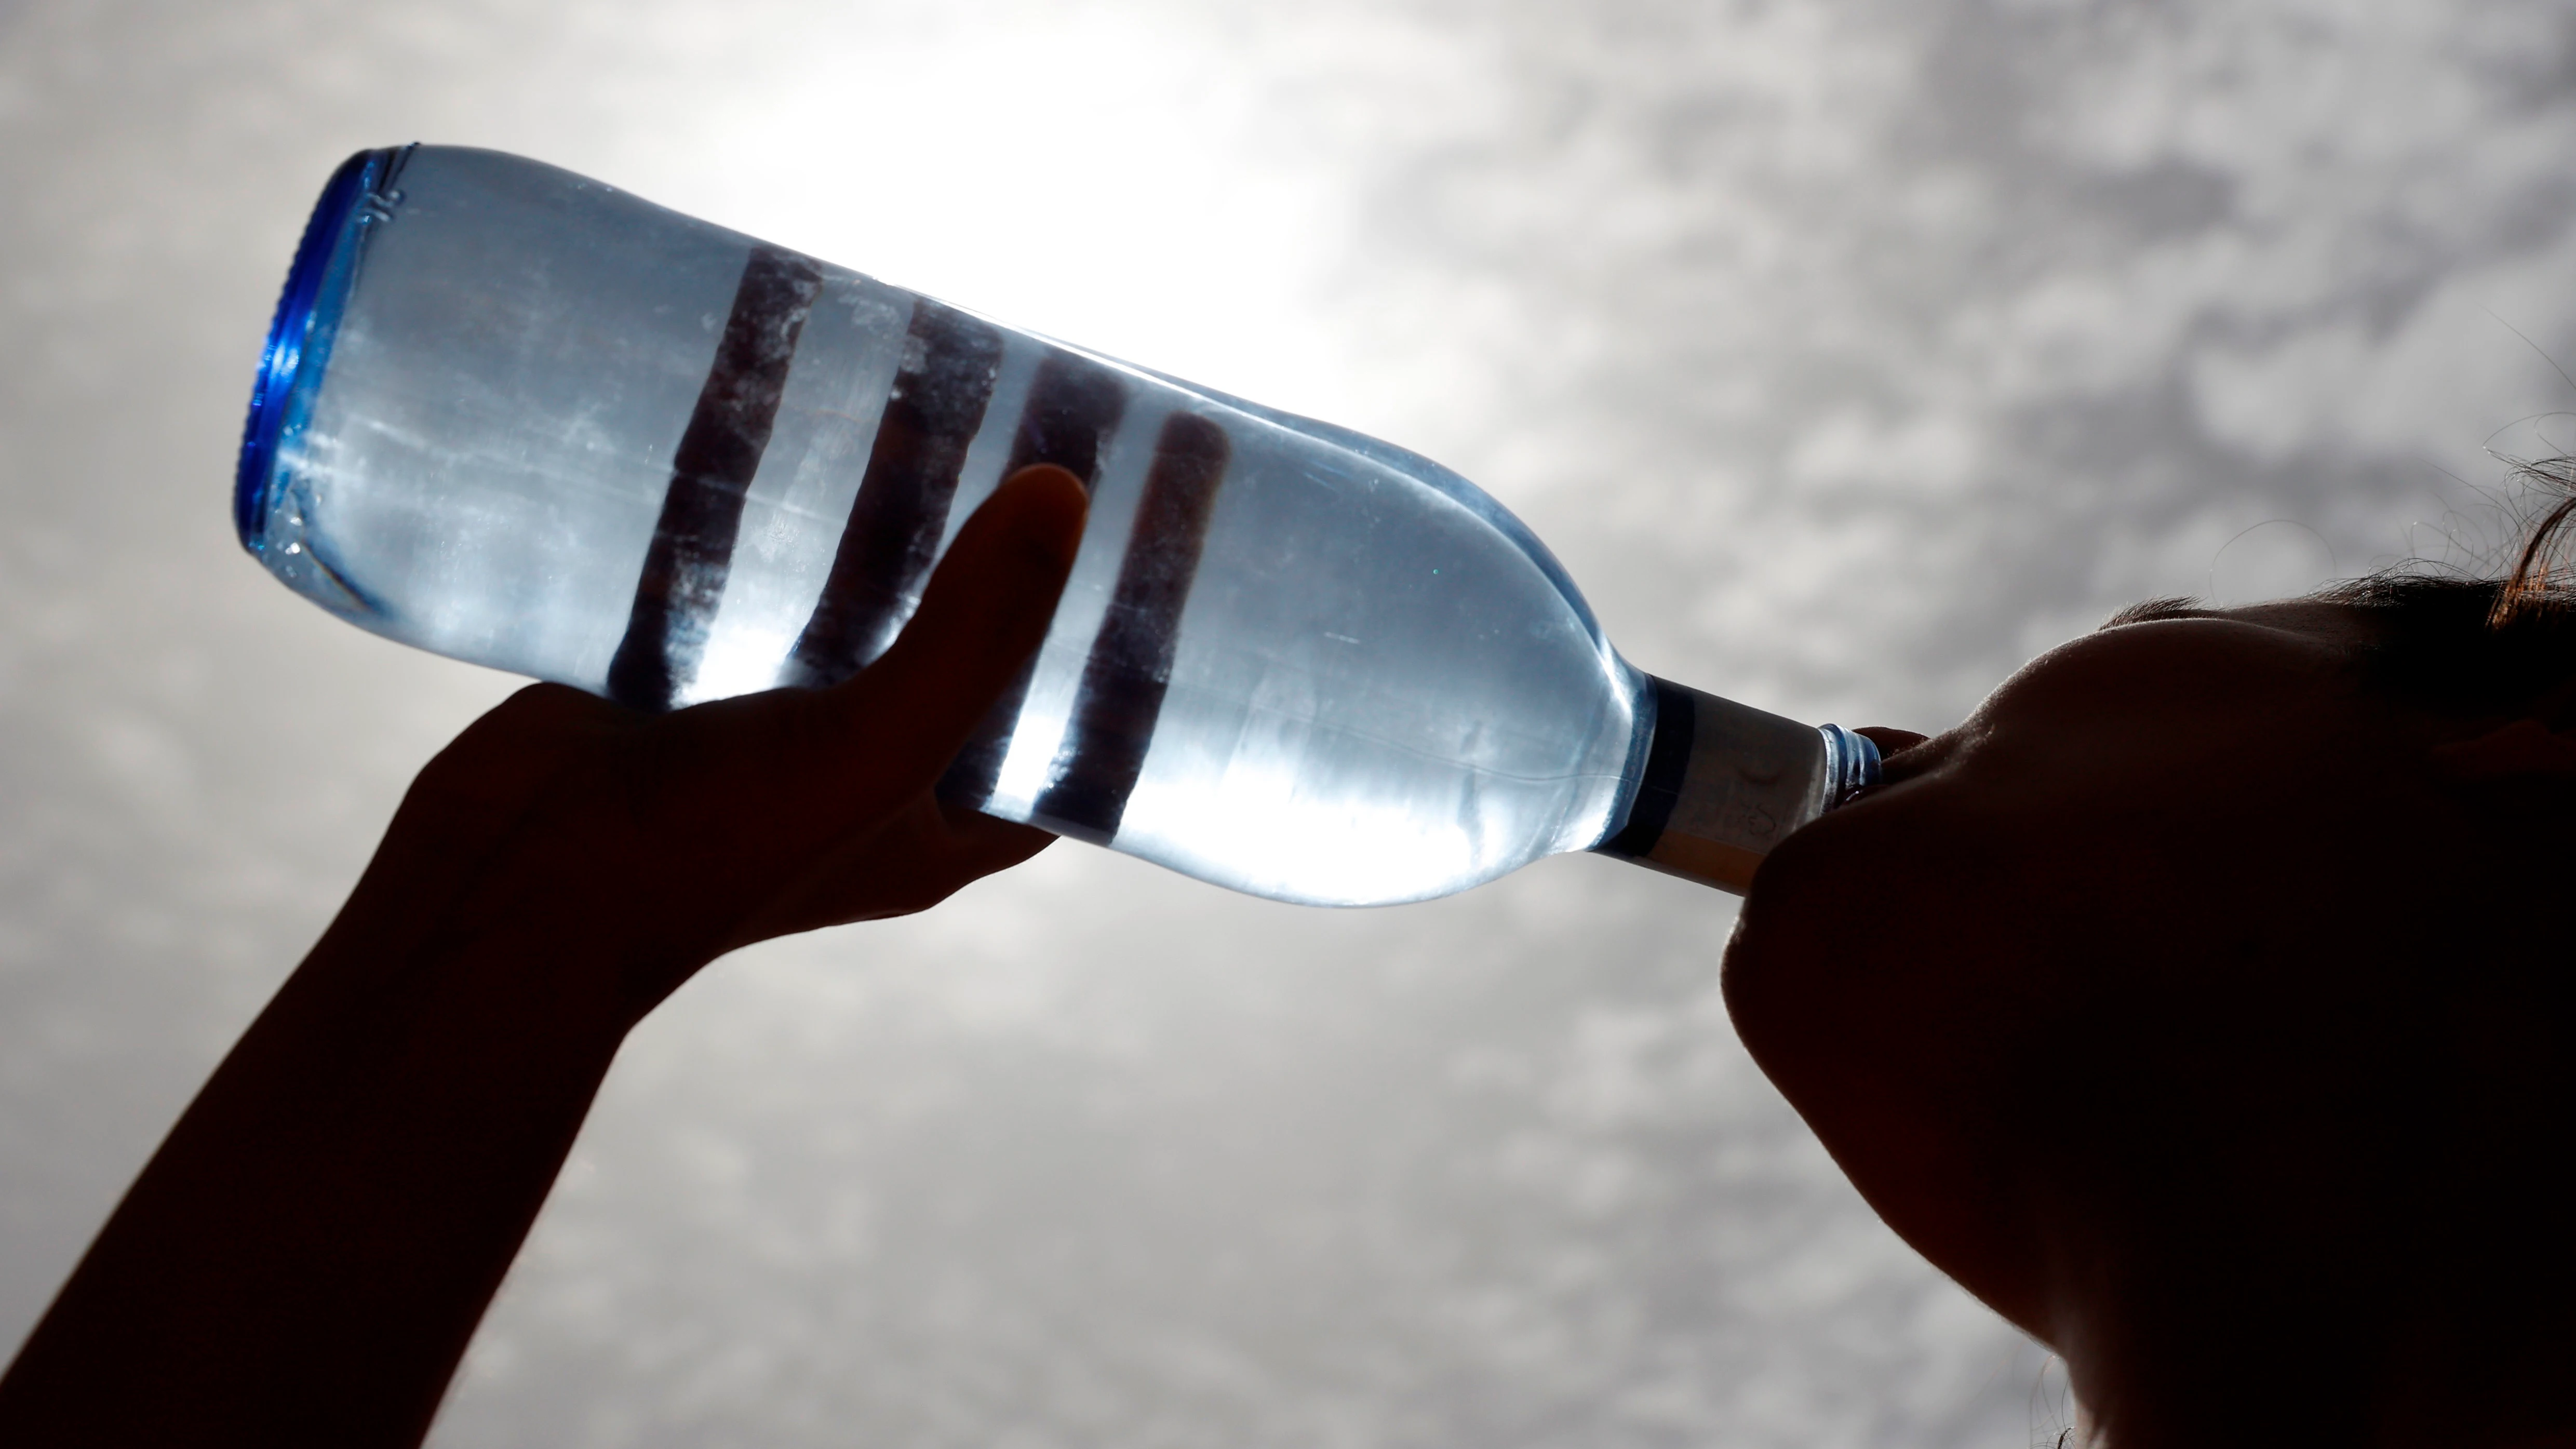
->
[0,0,2576,1449]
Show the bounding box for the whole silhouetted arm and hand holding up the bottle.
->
[0,469,1082,1446]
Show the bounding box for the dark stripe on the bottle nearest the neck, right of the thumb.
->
[1036,412,1234,846]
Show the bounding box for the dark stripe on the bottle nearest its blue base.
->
[608,245,822,709]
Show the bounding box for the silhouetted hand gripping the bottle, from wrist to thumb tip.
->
[325,456,1087,1024]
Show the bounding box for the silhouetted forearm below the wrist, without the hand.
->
[0,918,628,1446]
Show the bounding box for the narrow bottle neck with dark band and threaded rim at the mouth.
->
[1594,676,1878,895]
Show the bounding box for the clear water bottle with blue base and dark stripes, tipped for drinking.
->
[234,147,1878,905]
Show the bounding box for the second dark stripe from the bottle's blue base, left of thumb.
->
[781,297,1002,686]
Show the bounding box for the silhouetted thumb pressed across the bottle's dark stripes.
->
[824,464,1090,781]
